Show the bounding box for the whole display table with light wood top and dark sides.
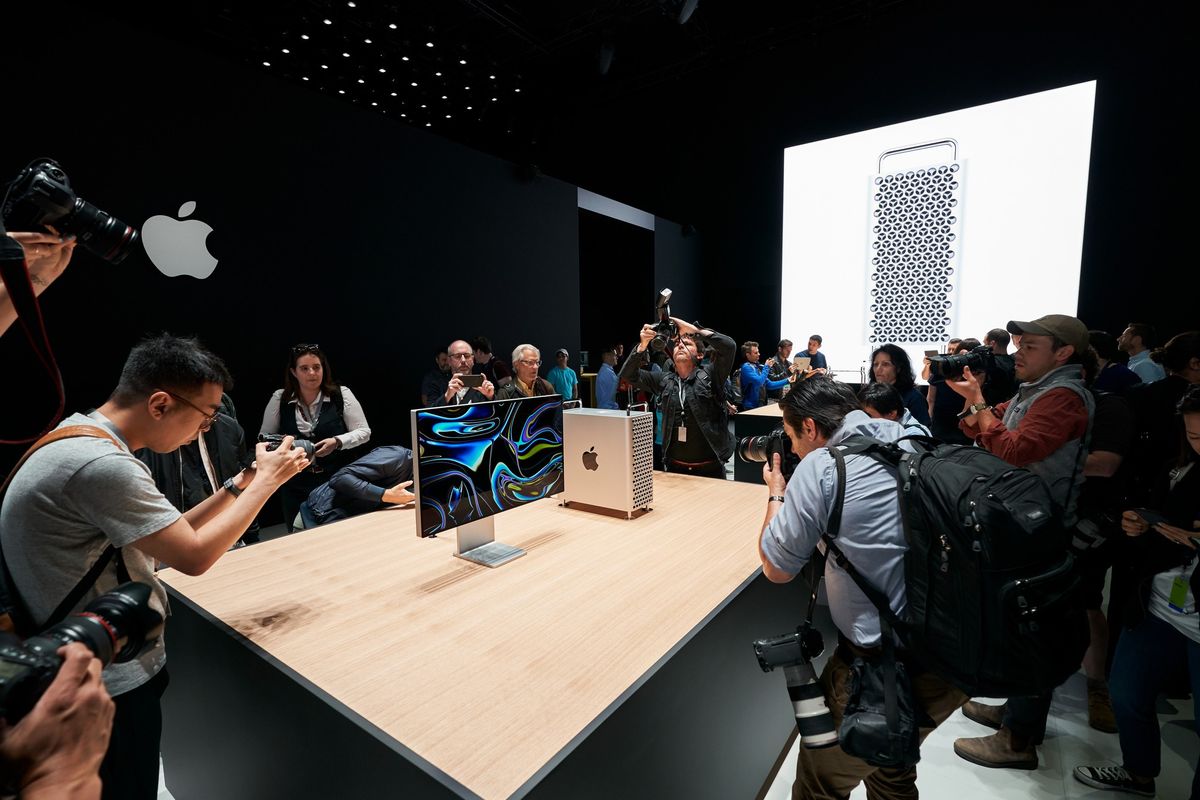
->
[162,473,804,800]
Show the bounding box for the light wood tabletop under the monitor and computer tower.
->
[161,473,767,798]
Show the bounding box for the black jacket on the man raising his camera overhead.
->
[619,331,738,462]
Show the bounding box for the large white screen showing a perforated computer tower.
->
[781,82,1096,380]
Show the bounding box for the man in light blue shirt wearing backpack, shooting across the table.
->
[758,377,966,798]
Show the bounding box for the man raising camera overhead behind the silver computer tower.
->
[620,317,738,480]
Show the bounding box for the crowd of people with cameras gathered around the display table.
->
[0,224,1200,798]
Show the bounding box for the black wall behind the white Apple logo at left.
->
[0,6,595,468]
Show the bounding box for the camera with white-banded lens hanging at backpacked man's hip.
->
[754,622,838,750]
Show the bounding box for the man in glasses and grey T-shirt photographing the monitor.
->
[0,335,308,800]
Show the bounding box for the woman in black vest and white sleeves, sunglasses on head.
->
[260,344,371,534]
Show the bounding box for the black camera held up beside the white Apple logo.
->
[0,158,140,264]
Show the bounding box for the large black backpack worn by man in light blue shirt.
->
[826,435,1088,697]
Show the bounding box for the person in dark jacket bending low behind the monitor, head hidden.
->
[300,445,413,528]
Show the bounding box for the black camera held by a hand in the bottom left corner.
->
[0,582,162,724]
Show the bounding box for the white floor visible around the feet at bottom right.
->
[766,673,1200,800]
